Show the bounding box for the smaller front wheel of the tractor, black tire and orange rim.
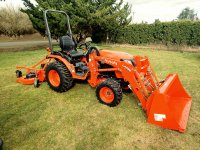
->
[96,79,122,107]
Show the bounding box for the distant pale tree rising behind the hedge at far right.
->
[178,7,197,20]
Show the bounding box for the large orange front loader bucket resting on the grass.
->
[147,74,192,132]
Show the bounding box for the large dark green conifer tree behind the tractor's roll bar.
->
[22,0,132,42]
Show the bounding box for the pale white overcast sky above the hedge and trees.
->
[0,0,200,23]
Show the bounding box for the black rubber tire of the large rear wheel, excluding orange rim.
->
[46,61,74,93]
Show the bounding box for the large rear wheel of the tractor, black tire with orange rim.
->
[45,61,74,93]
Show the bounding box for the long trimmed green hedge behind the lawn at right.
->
[116,21,200,45]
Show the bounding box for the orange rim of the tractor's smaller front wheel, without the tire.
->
[99,87,114,103]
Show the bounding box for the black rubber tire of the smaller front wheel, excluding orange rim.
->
[96,79,123,107]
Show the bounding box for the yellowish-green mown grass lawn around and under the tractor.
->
[0,46,200,150]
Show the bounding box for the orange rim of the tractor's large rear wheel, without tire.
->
[48,70,60,87]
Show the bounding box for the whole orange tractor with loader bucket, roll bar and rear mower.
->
[16,10,192,132]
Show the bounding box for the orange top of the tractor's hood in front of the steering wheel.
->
[100,49,133,60]
